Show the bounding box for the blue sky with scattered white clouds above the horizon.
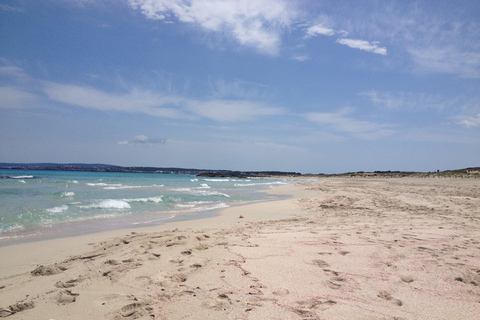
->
[0,0,480,173]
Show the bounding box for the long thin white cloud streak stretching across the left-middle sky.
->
[39,82,283,122]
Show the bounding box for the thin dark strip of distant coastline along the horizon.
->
[0,163,480,178]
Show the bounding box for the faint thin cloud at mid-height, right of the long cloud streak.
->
[304,110,395,139]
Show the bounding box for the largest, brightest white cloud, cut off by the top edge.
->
[129,0,296,55]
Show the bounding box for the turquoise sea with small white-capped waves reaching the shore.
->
[0,170,289,246]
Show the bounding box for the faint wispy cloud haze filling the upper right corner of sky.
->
[328,1,480,78]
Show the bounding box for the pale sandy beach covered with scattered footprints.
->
[0,178,480,320]
